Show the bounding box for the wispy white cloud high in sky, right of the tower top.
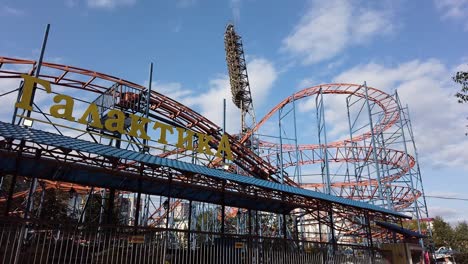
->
[282,0,393,64]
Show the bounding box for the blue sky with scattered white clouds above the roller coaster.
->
[0,0,468,222]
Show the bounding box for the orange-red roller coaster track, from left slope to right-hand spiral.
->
[0,53,422,229]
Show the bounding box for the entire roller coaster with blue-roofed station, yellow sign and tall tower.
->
[0,25,427,263]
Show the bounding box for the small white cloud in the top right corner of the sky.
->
[434,0,468,30]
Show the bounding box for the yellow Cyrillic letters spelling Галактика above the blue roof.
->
[15,74,234,160]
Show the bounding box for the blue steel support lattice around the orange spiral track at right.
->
[244,84,427,243]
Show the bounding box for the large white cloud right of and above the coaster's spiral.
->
[334,59,468,170]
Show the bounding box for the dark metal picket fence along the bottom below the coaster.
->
[0,221,381,264]
